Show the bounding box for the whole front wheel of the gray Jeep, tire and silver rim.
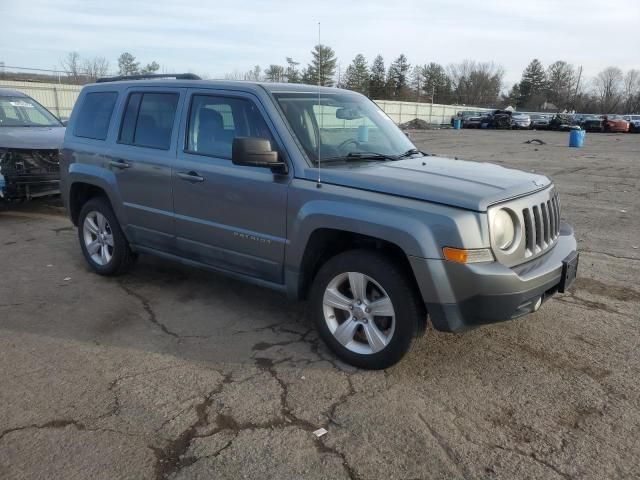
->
[309,250,426,370]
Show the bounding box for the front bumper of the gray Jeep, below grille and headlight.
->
[410,223,577,332]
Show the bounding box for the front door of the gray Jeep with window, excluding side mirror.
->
[173,90,290,283]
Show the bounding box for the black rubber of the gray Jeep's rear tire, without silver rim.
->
[78,197,137,276]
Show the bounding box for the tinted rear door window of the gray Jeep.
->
[119,93,179,150]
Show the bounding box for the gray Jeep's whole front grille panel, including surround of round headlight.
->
[488,186,560,267]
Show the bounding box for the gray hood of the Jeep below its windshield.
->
[305,157,551,212]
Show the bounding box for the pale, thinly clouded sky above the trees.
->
[0,0,640,84]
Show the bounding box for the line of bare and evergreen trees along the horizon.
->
[31,48,640,113]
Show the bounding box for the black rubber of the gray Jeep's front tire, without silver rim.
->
[308,250,426,370]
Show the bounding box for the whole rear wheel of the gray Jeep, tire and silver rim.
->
[78,197,137,276]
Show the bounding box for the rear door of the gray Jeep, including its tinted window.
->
[110,87,186,252]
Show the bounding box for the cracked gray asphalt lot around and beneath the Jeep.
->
[0,130,640,480]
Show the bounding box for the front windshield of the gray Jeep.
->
[274,91,419,162]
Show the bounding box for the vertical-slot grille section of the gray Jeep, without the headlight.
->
[522,191,560,258]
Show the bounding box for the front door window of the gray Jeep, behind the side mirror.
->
[187,95,275,158]
